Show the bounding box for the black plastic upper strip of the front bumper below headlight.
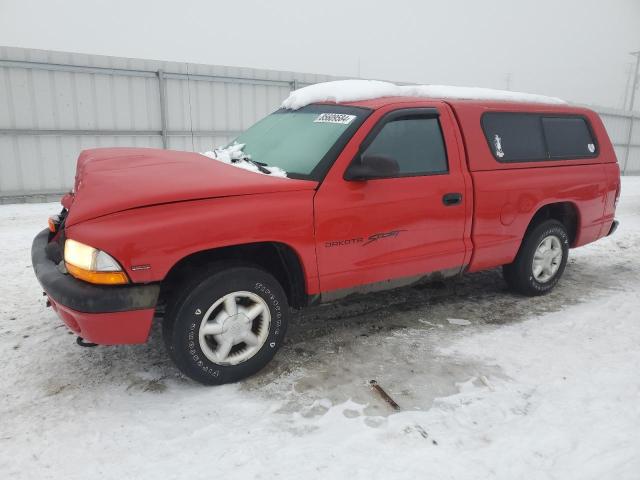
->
[31,229,160,313]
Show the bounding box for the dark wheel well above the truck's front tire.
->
[160,242,307,308]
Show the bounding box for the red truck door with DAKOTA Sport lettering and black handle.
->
[314,104,470,292]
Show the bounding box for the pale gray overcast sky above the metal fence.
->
[0,0,640,109]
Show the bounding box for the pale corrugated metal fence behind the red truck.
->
[0,47,640,203]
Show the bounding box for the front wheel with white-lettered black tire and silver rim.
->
[163,266,289,385]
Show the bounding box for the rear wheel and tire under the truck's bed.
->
[502,220,569,297]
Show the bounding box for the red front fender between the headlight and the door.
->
[66,190,318,293]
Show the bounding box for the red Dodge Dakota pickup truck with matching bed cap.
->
[32,84,620,384]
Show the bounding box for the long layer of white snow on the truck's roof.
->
[282,80,567,110]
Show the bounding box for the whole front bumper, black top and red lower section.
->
[31,230,160,344]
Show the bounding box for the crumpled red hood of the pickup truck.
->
[63,148,318,225]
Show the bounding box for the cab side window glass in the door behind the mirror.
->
[365,117,449,177]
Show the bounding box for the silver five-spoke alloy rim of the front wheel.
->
[198,291,271,365]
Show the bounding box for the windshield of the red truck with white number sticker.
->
[230,105,370,180]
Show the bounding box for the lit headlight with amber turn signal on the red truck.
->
[64,239,129,285]
